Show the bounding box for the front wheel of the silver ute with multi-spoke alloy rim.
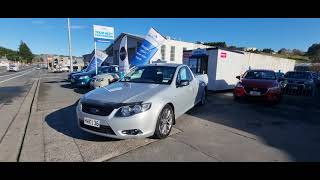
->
[154,104,174,139]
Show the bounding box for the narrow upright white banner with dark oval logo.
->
[119,35,129,74]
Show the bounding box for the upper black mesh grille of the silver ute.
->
[82,103,113,116]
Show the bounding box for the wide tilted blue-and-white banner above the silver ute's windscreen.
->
[131,28,166,66]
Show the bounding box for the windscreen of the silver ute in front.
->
[120,66,176,84]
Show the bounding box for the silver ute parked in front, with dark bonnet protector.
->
[76,64,206,139]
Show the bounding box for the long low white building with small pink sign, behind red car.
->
[183,48,295,91]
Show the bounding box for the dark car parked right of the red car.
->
[281,71,316,95]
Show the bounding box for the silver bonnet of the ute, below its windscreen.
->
[84,82,169,103]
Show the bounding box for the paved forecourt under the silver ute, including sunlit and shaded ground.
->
[19,73,320,161]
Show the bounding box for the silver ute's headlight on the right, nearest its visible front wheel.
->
[116,103,151,117]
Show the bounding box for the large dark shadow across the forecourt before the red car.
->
[187,90,320,161]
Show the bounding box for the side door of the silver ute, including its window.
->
[173,66,194,116]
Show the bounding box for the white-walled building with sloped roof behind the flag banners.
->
[105,33,210,64]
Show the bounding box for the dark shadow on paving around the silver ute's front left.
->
[45,102,118,141]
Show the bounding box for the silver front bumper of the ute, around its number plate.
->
[76,102,158,139]
